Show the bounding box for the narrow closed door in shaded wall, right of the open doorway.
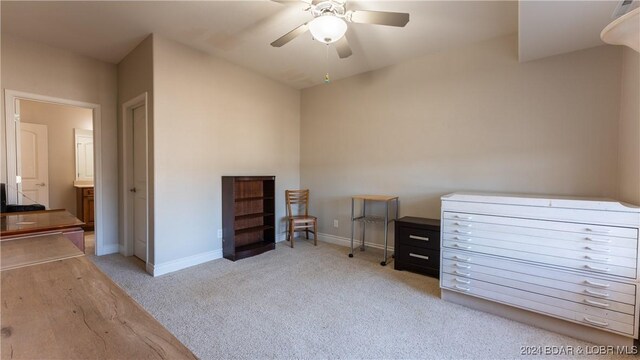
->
[131,105,147,262]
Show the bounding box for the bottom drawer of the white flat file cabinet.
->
[441,273,635,335]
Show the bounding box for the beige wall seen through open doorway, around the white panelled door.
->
[20,100,93,215]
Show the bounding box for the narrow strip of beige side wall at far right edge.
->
[619,47,640,205]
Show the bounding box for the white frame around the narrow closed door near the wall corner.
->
[121,92,150,264]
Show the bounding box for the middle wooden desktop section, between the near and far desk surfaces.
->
[0,234,84,271]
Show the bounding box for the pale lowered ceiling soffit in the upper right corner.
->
[518,0,638,61]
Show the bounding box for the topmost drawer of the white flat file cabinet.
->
[444,211,638,239]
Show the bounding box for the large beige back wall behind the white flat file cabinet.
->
[301,36,621,246]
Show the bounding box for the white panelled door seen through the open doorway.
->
[18,123,49,208]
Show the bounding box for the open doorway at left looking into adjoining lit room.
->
[5,90,102,255]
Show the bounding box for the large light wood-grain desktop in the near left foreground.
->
[0,255,196,359]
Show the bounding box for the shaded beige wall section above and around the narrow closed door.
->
[118,35,154,263]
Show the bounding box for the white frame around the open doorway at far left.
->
[4,89,104,255]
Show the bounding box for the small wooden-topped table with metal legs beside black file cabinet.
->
[349,195,398,266]
